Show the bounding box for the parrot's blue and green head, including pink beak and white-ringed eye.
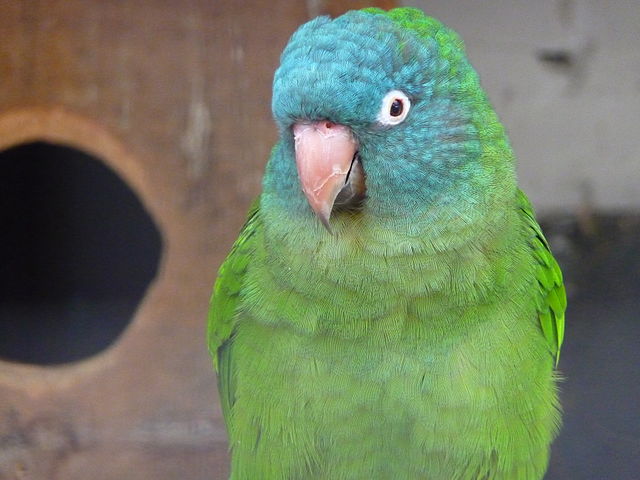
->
[265,8,515,229]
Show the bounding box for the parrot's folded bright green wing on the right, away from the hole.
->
[518,190,567,365]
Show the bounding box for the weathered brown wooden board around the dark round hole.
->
[0,0,391,480]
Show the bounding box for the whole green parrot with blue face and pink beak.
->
[208,8,566,480]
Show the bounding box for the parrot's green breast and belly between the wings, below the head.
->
[229,207,558,480]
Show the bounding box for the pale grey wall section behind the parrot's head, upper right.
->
[401,0,640,212]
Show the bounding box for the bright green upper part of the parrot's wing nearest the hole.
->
[207,197,261,370]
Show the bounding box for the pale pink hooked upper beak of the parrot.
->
[293,120,358,231]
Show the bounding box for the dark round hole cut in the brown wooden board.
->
[0,142,162,365]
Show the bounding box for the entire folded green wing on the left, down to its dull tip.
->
[207,197,260,418]
